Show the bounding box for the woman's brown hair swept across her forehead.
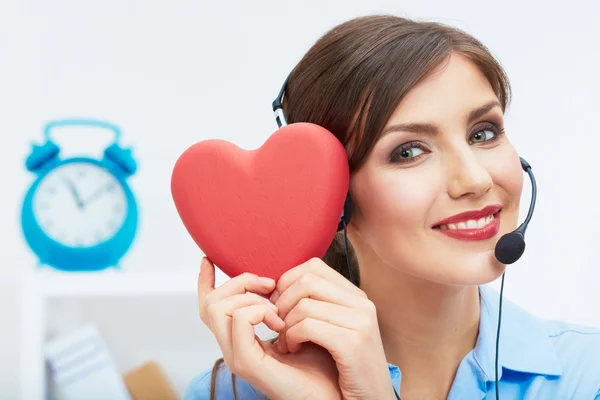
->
[210,15,510,399]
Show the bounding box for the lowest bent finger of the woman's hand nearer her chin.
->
[285,318,348,358]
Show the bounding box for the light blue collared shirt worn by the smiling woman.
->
[184,286,600,400]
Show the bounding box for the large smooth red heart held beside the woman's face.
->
[171,122,350,280]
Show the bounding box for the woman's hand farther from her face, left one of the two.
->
[198,258,342,400]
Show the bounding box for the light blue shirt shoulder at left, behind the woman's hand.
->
[183,363,261,400]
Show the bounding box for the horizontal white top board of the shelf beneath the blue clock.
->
[27,270,198,298]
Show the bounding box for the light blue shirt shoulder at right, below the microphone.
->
[476,287,600,400]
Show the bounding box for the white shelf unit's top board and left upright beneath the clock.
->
[21,268,229,400]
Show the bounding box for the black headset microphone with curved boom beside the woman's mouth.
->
[495,158,537,264]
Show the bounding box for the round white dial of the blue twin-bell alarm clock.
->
[33,162,127,247]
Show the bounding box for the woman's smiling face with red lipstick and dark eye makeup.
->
[351,54,523,285]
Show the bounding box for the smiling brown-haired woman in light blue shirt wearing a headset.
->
[185,15,600,400]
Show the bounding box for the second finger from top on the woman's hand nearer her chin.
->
[275,273,368,319]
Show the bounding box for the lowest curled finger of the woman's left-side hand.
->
[231,304,284,371]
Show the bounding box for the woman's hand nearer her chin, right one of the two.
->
[271,259,396,400]
